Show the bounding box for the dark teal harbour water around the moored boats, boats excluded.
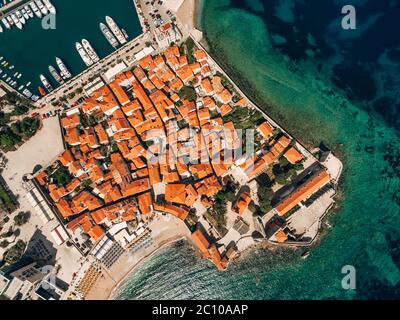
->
[0,0,142,94]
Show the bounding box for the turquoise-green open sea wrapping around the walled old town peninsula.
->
[118,0,400,299]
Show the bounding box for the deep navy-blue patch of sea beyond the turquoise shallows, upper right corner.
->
[230,0,400,130]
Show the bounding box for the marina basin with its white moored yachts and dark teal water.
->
[0,0,141,99]
